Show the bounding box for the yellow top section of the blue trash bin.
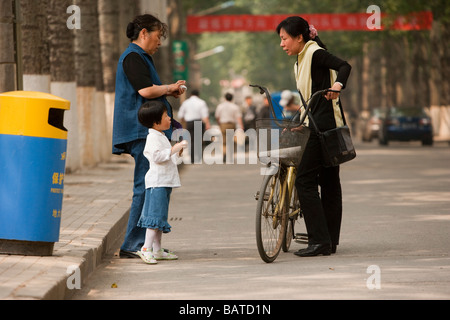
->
[0,91,70,139]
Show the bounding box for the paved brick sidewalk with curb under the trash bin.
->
[0,156,133,300]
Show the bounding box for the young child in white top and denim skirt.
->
[137,101,187,264]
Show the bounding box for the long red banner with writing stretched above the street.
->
[187,11,433,34]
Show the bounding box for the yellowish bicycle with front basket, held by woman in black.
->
[250,85,336,263]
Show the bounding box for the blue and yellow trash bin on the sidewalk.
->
[0,91,70,256]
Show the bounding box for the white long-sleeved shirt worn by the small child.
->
[144,129,181,189]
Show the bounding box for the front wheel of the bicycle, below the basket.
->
[256,173,287,263]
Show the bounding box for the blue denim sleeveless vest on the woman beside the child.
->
[112,43,173,154]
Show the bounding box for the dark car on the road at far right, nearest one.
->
[378,107,433,146]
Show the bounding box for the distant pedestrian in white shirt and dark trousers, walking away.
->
[178,90,211,163]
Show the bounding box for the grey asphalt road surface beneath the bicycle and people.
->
[73,142,450,300]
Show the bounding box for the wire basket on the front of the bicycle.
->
[256,119,311,166]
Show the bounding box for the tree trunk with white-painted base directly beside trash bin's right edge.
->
[47,0,81,172]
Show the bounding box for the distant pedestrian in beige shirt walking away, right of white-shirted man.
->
[215,93,244,160]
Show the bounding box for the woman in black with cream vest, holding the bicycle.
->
[277,16,351,257]
